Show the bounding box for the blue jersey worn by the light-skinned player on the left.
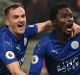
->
[0,25,38,75]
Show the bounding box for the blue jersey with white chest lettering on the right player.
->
[29,32,80,75]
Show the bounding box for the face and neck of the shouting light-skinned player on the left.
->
[6,7,26,37]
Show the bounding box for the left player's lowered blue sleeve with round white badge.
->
[0,42,17,65]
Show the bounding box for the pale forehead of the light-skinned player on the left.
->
[9,7,25,15]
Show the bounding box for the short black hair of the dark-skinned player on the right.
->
[50,3,69,20]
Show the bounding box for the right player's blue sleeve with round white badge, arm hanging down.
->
[29,44,45,75]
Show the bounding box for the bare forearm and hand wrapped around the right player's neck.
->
[37,20,80,37]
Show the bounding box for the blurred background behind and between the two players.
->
[0,0,80,75]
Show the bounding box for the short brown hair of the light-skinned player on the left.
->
[3,3,23,17]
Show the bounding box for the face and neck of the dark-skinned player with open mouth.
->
[52,8,74,42]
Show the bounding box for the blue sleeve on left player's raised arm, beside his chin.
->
[25,24,38,37]
